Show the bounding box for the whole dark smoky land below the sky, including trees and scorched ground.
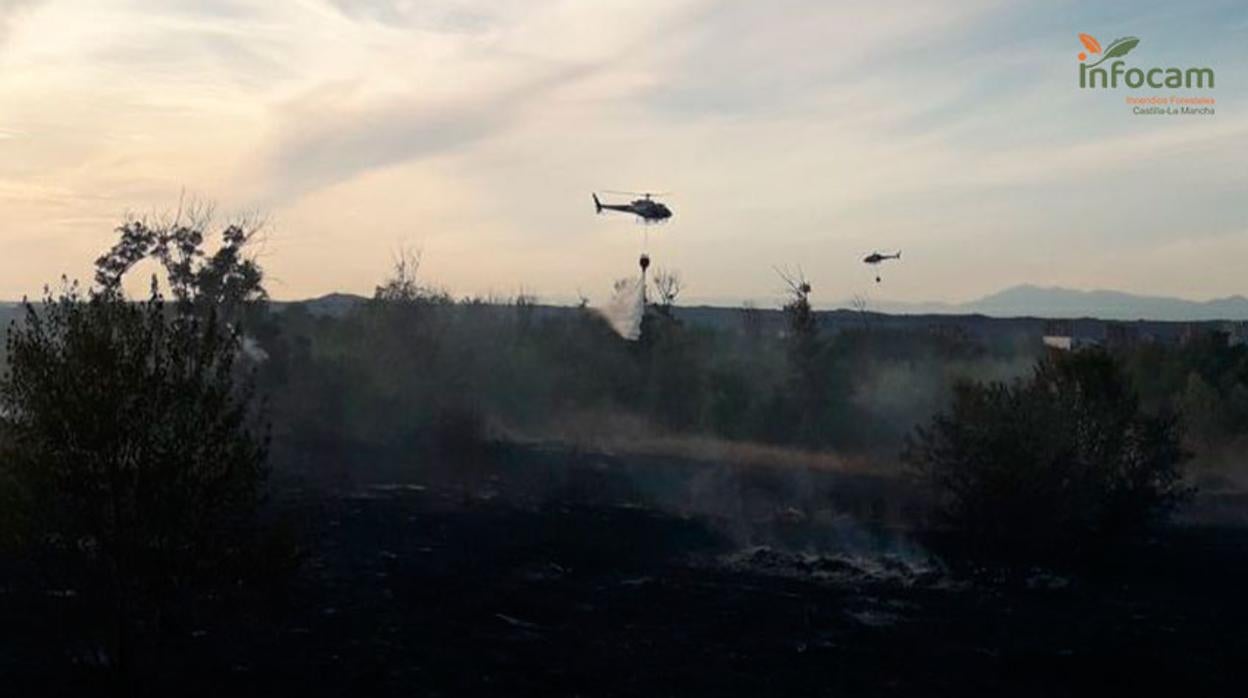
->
[0,243,1248,697]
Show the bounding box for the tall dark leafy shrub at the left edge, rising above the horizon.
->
[0,218,267,676]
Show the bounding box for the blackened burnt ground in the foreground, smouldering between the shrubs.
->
[0,448,1248,696]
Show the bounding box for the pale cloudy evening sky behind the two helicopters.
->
[0,0,1248,305]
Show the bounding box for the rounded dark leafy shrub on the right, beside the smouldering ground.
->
[904,351,1188,552]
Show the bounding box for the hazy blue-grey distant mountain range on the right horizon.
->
[844,285,1248,322]
